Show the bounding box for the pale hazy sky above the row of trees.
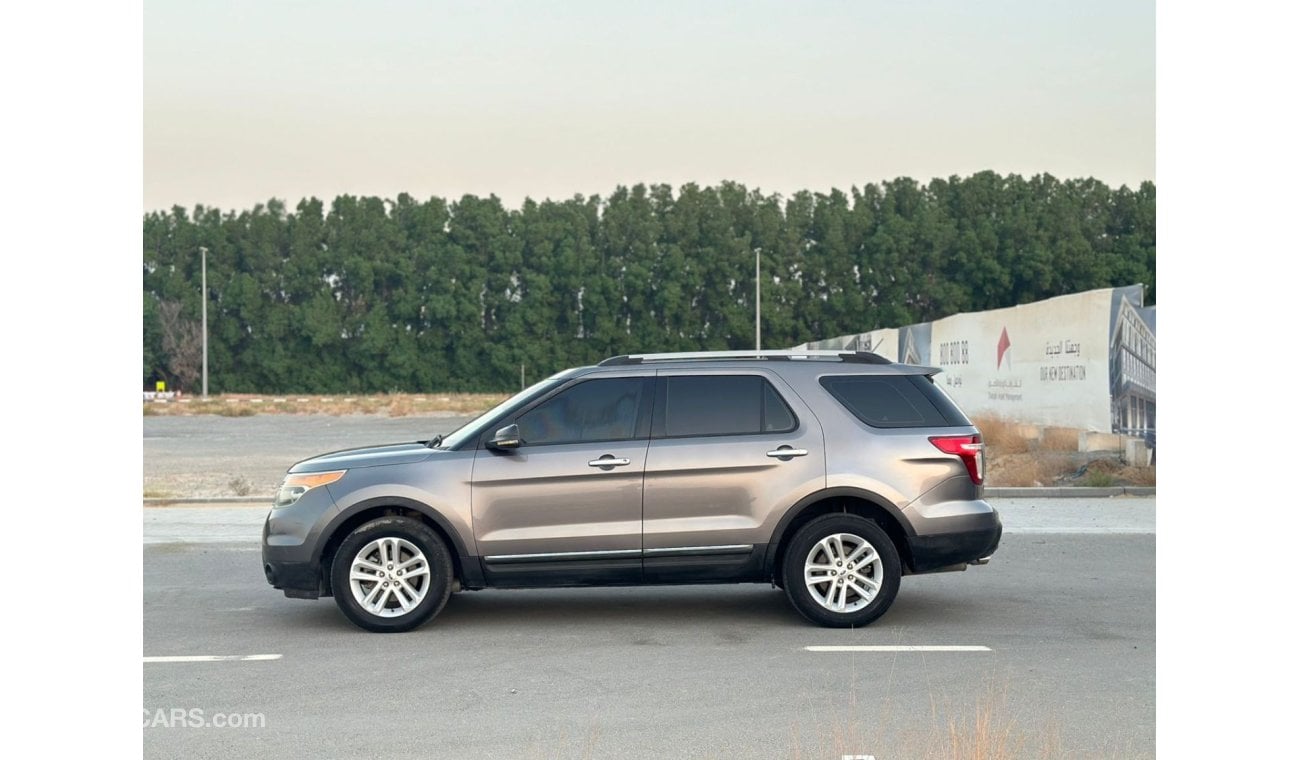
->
[143,0,1156,210]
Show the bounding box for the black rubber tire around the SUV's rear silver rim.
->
[781,513,902,627]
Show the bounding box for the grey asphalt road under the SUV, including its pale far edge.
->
[143,499,1156,760]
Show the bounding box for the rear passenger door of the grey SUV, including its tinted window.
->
[644,369,826,582]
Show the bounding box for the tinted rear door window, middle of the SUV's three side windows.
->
[655,375,798,438]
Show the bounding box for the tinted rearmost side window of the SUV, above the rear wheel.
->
[822,374,970,427]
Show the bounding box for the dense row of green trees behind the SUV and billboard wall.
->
[144,171,1156,392]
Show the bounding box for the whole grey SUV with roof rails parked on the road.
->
[261,351,1002,631]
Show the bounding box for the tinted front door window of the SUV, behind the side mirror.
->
[516,377,645,446]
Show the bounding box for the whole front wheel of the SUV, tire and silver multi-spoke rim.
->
[330,517,452,633]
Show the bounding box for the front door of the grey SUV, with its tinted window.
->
[471,370,654,586]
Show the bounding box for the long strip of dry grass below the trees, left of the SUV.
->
[143,394,506,417]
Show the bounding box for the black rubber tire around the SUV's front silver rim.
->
[330,517,454,633]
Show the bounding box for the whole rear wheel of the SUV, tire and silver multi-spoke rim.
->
[781,513,902,627]
